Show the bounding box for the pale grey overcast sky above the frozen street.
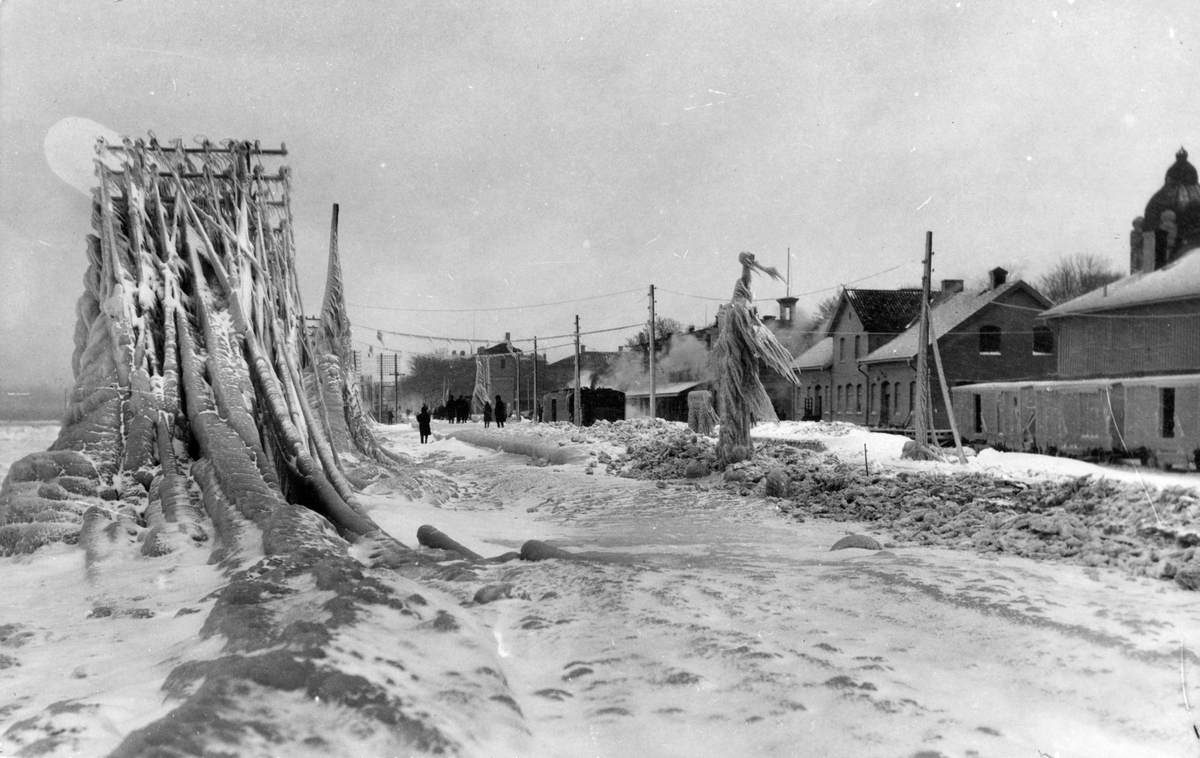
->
[0,0,1200,385]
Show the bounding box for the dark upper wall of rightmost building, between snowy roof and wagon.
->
[1050,299,1200,379]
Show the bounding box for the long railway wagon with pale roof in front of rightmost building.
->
[952,374,1200,469]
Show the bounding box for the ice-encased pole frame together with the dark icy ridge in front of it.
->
[0,139,521,756]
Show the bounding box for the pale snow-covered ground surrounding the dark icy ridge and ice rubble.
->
[0,422,1200,758]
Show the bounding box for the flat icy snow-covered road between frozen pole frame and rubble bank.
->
[372,431,1200,758]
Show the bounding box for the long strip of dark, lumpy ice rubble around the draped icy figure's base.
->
[595,425,1200,589]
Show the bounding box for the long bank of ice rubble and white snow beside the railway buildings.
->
[424,419,1200,590]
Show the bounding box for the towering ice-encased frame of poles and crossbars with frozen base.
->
[0,134,417,553]
